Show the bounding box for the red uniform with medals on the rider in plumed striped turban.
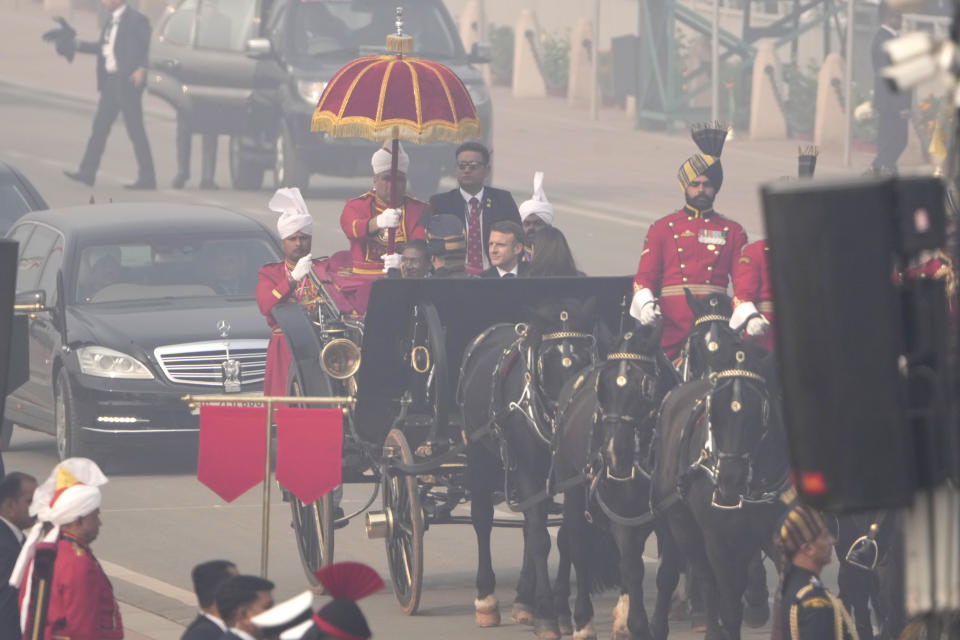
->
[633,205,747,358]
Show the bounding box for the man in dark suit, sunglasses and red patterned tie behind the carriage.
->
[430,142,520,274]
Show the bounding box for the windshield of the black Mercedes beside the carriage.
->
[74,234,278,304]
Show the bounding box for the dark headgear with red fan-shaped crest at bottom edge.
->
[306,562,384,640]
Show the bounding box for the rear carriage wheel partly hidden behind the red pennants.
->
[287,362,335,584]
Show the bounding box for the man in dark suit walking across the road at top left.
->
[58,0,157,189]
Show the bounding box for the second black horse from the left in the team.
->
[552,327,679,640]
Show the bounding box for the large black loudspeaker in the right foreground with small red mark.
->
[762,179,917,512]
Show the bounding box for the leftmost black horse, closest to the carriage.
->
[457,299,598,640]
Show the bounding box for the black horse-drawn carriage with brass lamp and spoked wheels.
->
[273,278,630,614]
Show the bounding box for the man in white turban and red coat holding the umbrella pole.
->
[340,143,430,276]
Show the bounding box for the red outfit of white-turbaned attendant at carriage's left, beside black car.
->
[256,260,322,396]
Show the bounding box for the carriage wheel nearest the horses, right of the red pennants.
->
[382,429,423,616]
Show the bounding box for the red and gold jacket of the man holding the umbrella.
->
[340,191,430,276]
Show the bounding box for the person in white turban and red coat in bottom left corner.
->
[10,458,123,640]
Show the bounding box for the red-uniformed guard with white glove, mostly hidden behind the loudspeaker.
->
[730,146,818,351]
